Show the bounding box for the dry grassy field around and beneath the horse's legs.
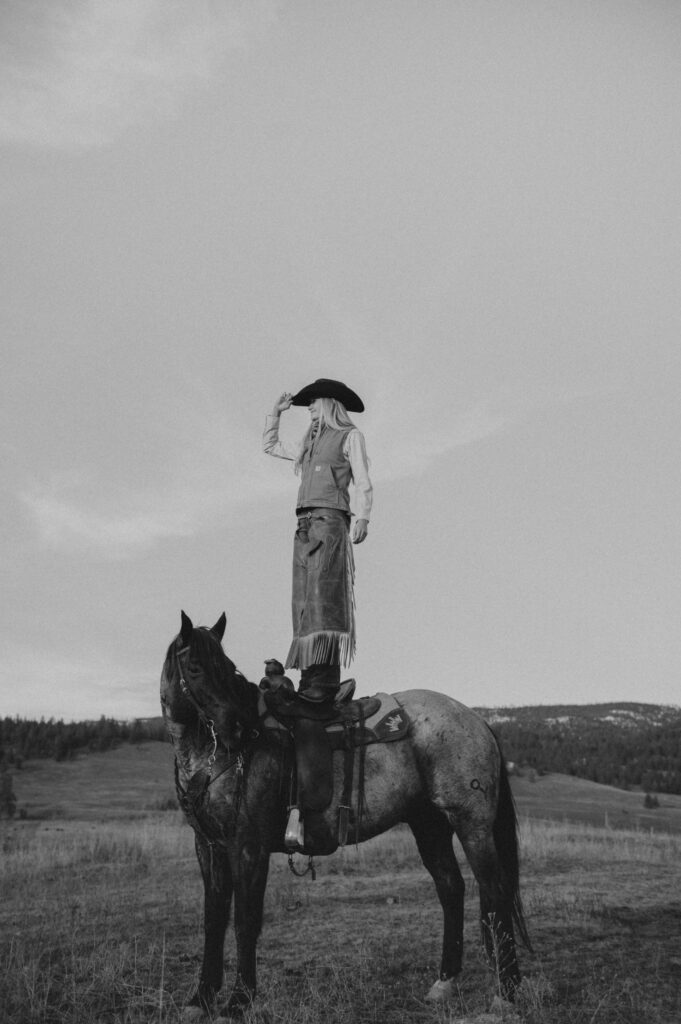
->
[0,743,681,1024]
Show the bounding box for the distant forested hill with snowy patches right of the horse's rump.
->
[478,702,681,794]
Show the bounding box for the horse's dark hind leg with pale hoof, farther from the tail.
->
[410,808,465,1000]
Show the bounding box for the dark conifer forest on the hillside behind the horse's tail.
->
[485,709,681,794]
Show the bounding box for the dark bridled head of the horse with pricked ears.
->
[161,611,257,749]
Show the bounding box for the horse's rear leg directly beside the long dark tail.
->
[459,833,520,1001]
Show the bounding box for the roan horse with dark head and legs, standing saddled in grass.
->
[161,612,529,1014]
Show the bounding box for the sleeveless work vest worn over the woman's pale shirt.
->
[296,427,353,514]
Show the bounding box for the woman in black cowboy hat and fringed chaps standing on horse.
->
[262,379,373,701]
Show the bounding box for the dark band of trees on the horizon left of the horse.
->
[0,716,167,768]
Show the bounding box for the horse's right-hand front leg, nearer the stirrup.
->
[227,840,269,1013]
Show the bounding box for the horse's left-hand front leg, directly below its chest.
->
[188,836,232,1010]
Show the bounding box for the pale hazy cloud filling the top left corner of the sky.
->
[0,0,280,148]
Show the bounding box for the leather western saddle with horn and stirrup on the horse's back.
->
[262,679,410,845]
